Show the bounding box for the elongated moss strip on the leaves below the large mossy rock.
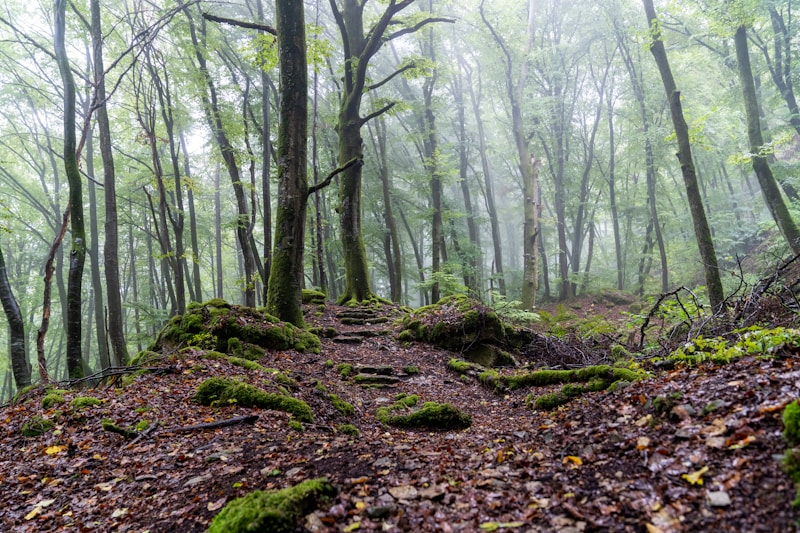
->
[194,378,314,422]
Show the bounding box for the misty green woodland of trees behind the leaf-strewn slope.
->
[0,0,800,390]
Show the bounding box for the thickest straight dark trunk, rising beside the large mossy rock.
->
[267,0,308,327]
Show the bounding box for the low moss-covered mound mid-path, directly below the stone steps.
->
[375,394,472,429]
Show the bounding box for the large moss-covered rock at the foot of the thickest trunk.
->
[150,300,320,359]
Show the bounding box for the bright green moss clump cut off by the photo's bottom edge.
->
[208,478,337,533]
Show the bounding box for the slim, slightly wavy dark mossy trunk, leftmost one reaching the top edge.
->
[54,0,86,379]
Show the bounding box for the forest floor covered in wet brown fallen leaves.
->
[0,301,800,533]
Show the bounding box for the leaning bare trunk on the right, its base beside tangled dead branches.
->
[642,0,725,311]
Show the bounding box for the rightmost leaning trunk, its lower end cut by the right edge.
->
[734,26,800,254]
